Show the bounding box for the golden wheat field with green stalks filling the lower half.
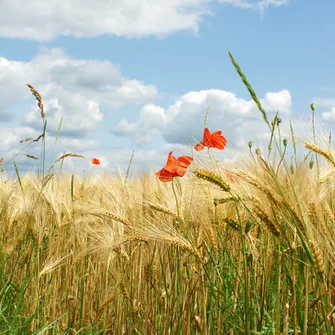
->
[0,54,335,335]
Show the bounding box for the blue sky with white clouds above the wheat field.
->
[0,0,335,178]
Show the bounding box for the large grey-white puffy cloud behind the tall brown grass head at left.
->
[0,48,157,137]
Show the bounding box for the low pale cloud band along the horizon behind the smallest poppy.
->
[0,122,166,175]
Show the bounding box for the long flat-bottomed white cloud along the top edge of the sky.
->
[0,0,289,42]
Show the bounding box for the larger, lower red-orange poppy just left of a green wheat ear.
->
[156,151,193,182]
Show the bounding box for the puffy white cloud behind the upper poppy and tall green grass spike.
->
[111,89,292,147]
